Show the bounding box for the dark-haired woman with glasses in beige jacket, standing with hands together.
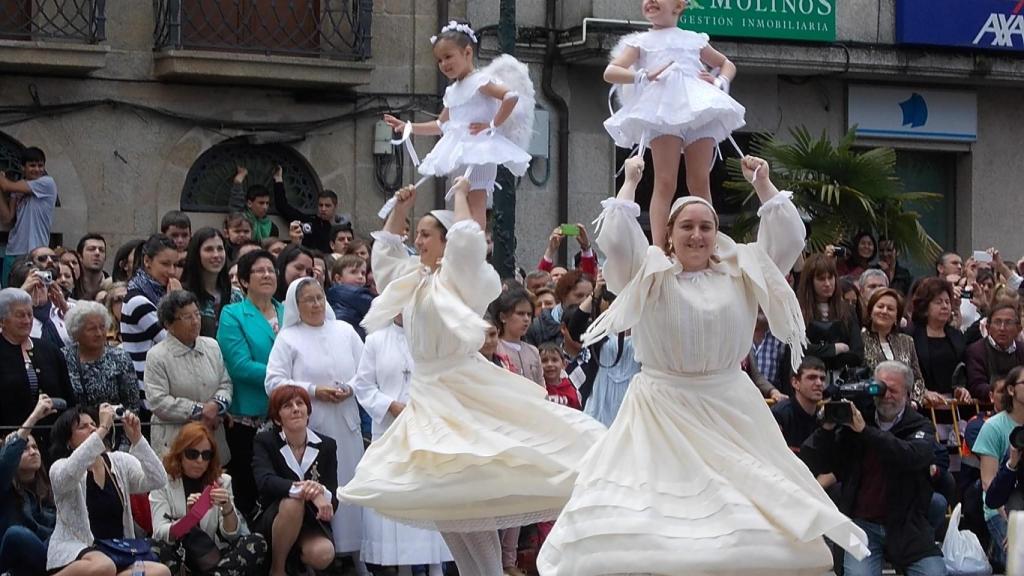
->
[145,290,231,461]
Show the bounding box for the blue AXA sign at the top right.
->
[896,0,1024,51]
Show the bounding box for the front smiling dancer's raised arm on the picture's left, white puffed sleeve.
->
[597,157,649,293]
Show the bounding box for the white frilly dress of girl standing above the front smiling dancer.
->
[604,28,746,148]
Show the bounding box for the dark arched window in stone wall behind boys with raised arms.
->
[181,138,322,213]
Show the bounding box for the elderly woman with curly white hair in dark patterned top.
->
[62,300,139,413]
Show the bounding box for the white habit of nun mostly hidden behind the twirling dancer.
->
[352,318,452,576]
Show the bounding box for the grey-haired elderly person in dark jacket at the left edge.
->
[0,288,75,445]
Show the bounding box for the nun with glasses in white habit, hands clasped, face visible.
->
[266,278,369,574]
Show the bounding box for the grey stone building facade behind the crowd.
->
[0,0,1024,269]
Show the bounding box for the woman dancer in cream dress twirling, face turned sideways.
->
[338,178,604,576]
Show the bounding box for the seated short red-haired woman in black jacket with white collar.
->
[253,384,338,576]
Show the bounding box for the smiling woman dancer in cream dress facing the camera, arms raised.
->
[538,157,867,576]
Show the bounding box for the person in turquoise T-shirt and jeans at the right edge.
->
[972,366,1024,565]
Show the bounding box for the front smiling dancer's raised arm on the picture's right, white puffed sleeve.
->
[741,156,804,275]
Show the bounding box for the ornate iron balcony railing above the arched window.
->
[152,0,374,60]
